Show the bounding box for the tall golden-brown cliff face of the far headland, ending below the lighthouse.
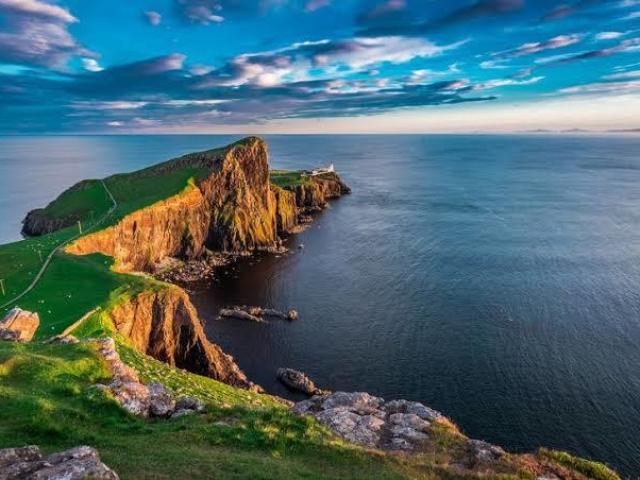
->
[66,137,349,272]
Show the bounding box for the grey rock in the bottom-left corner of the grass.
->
[0,446,119,480]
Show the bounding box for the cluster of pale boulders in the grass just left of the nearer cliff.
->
[97,338,204,418]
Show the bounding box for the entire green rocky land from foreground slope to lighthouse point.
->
[0,137,620,480]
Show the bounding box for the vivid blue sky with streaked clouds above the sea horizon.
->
[0,0,640,134]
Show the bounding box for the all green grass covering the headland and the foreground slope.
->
[0,141,619,480]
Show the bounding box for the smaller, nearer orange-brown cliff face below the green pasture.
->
[106,287,260,390]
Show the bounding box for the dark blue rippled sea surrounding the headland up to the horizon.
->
[0,135,640,475]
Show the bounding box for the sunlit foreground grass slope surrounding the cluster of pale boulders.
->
[0,343,424,479]
